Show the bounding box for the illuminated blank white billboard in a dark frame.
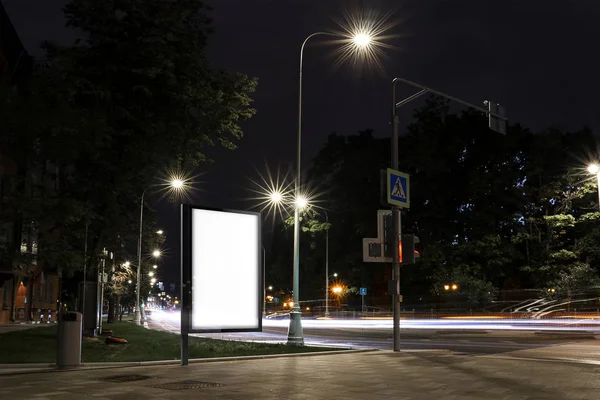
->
[186,207,263,332]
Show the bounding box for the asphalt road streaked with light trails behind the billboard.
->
[143,312,589,355]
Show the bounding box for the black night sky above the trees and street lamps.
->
[1,0,600,286]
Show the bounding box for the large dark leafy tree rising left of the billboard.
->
[2,0,256,296]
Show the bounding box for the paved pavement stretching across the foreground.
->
[0,351,600,400]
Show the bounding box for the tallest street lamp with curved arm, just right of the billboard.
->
[287,31,372,346]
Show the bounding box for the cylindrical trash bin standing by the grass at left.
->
[56,312,81,368]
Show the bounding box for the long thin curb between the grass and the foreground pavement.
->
[0,349,379,377]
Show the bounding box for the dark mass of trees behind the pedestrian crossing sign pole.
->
[270,97,600,308]
